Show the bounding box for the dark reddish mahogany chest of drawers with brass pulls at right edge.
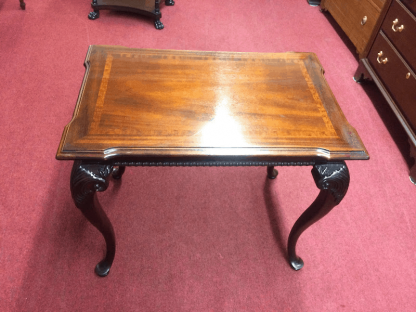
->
[354,0,416,183]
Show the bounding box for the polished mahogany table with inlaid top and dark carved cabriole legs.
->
[56,46,369,276]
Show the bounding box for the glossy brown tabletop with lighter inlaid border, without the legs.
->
[57,46,366,161]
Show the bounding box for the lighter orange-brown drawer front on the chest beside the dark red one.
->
[321,0,384,53]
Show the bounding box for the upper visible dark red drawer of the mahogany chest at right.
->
[381,0,416,70]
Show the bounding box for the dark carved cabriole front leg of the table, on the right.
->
[288,162,350,270]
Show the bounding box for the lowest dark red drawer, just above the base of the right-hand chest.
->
[368,31,416,132]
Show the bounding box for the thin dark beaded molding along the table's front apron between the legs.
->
[114,161,315,167]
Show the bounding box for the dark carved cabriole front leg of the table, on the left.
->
[71,160,116,276]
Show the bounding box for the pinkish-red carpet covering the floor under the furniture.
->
[0,0,416,312]
